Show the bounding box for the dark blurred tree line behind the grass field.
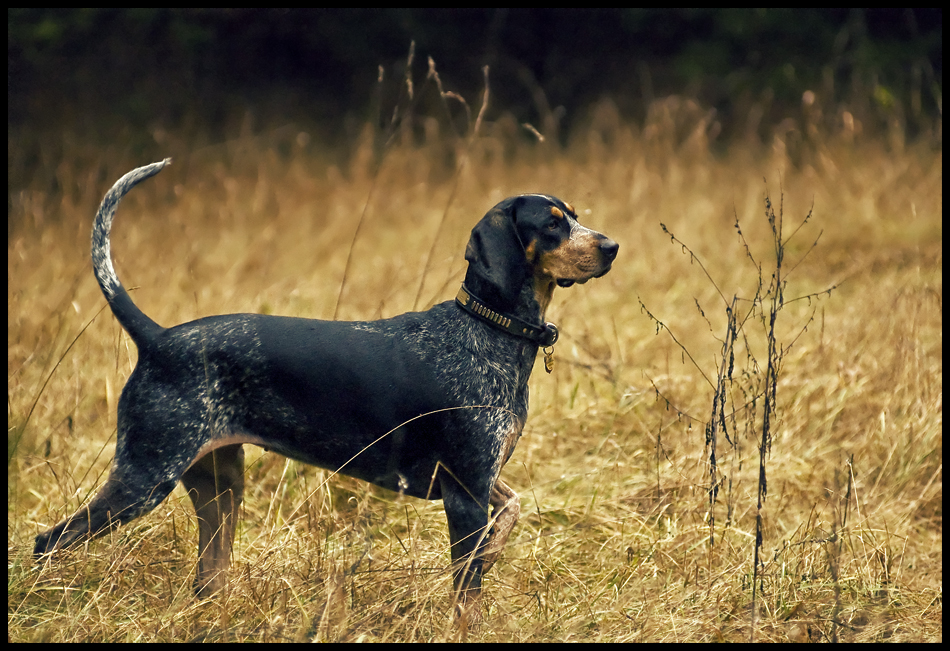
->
[7,8,943,142]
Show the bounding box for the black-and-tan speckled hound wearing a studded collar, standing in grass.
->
[34,160,618,619]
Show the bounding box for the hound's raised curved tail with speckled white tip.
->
[92,158,172,350]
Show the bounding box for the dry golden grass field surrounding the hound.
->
[8,100,943,642]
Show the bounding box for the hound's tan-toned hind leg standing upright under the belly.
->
[181,445,244,596]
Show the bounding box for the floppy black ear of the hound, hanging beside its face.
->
[465,197,531,309]
